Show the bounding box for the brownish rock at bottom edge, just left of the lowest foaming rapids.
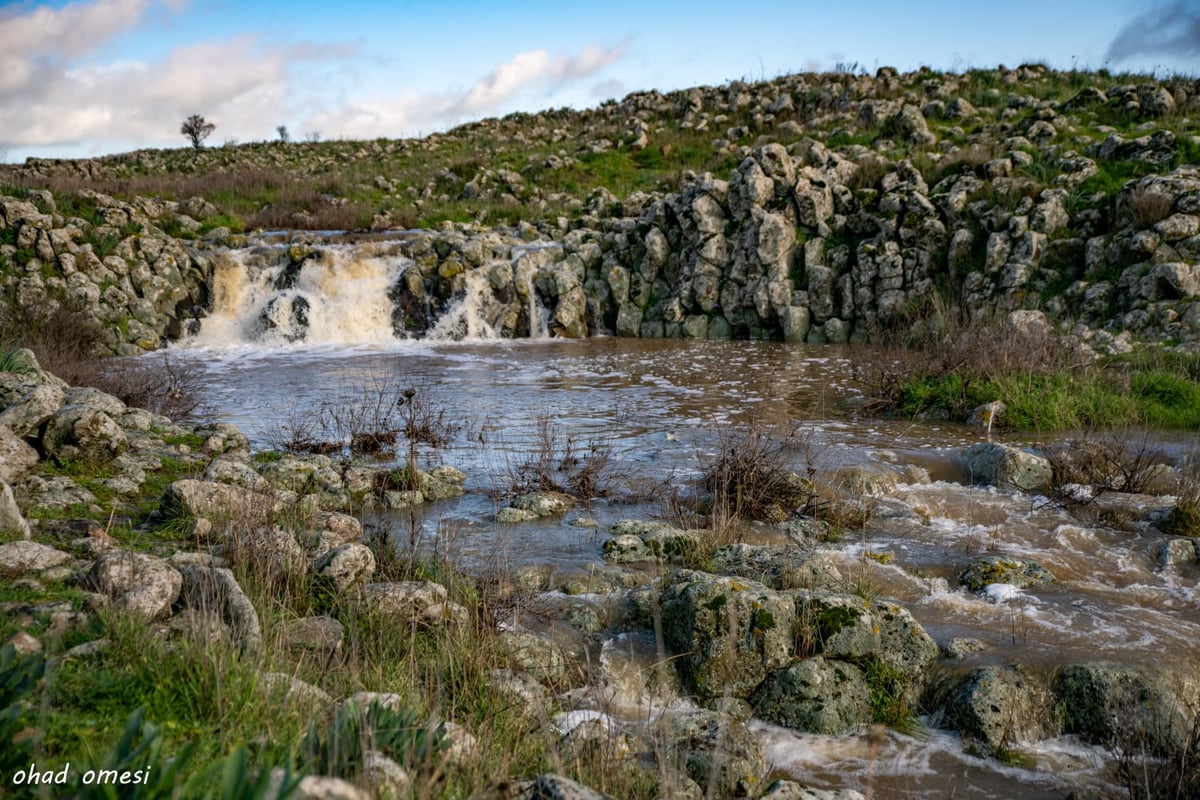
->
[665,710,767,798]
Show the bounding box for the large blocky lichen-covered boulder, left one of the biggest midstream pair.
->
[660,570,796,700]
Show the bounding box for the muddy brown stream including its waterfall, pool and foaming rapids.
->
[166,241,1200,798]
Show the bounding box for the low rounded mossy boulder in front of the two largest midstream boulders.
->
[750,656,871,735]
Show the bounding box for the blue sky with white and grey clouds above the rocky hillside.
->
[0,0,1200,162]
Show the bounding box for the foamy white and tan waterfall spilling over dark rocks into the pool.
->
[188,242,561,347]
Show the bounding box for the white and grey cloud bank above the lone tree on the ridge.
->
[0,0,622,158]
